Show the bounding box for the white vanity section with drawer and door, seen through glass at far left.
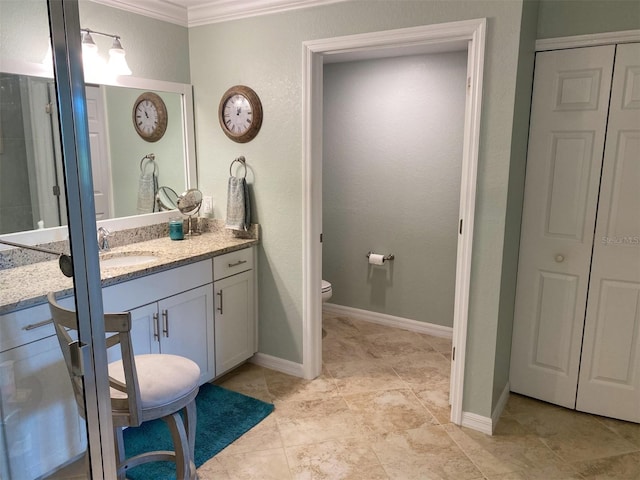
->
[0,304,86,479]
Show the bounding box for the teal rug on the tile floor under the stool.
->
[124,383,273,480]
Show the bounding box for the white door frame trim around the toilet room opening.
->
[302,18,487,425]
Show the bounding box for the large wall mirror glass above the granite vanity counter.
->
[0,60,196,235]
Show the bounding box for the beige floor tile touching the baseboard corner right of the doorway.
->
[443,418,564,477]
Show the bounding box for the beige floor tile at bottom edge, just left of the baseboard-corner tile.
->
[373,426,482,480]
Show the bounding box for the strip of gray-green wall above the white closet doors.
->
[538,0,640,38]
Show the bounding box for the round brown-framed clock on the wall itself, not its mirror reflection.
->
[218,85,262,143]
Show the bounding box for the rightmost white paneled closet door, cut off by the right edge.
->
[576,44,640,422]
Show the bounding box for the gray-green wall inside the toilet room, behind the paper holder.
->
[322,50,467,327]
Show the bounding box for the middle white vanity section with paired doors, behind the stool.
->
[102,260,215,384]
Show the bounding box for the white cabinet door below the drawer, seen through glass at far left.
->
[0,336,86,479]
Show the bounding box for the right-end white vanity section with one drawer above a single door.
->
[213,248,257,376]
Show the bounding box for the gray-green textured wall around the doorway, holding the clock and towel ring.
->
[189,0,522,416]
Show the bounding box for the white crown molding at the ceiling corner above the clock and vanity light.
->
[91,0,346,27]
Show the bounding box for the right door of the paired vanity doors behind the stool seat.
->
[158,284,215,384]
